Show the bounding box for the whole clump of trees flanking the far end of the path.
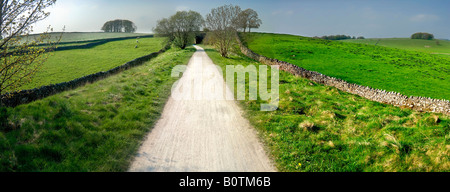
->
[153,5,262,57]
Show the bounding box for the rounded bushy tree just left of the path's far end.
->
[153,11,205,49]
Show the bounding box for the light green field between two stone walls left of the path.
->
[15,37,164,90]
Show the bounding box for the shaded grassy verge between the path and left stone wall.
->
[0,48,194,171]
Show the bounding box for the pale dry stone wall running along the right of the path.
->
[236,36,450,115]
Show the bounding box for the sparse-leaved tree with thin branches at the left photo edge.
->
[0,0,56,94]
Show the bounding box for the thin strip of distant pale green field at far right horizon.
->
[343,38,450,56]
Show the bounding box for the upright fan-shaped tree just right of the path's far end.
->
[206,5,241,57]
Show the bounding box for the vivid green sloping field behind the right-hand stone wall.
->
[243,33,450,100]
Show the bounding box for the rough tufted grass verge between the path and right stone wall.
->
[202,45,450,172]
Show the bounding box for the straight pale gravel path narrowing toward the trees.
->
[129,46,276,172]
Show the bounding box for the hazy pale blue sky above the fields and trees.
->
[35,0,450,39]
